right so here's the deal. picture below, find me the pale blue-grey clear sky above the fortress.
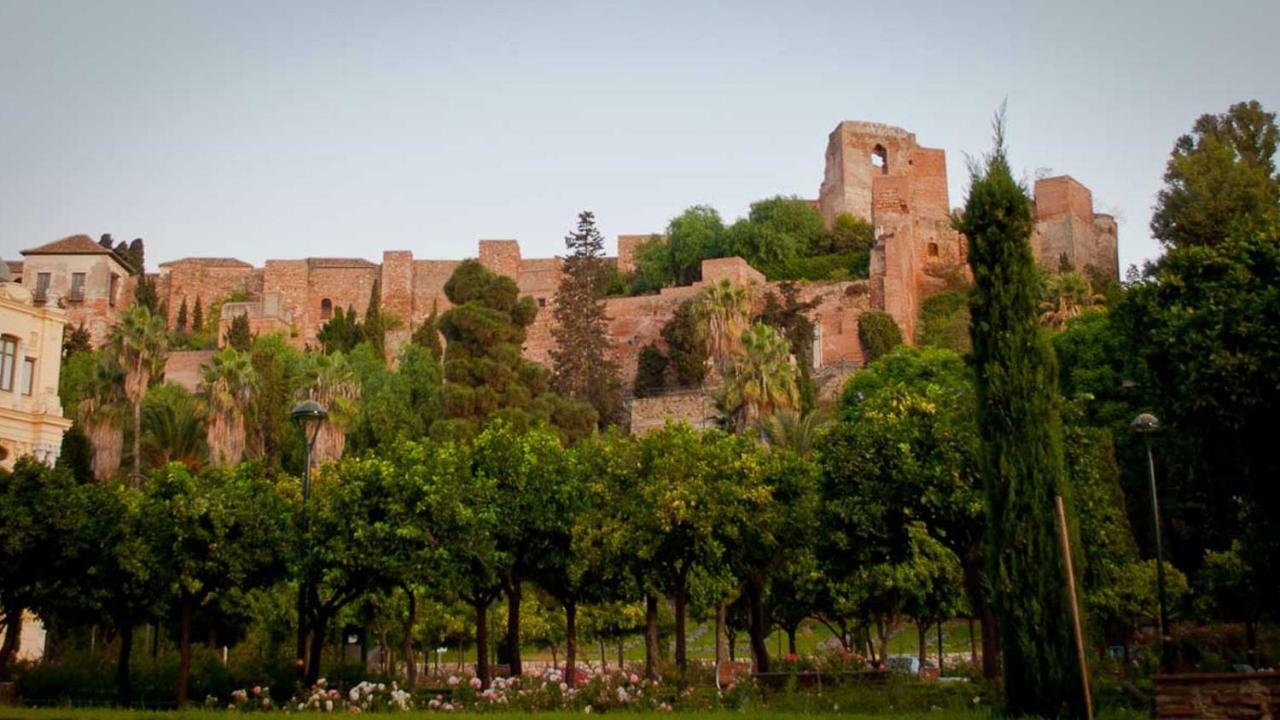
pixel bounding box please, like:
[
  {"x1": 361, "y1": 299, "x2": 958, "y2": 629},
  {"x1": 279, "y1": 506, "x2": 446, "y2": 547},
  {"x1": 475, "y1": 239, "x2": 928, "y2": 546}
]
[{"x1": 0, "y1": 0, "x2": 1280, "y2": 270}]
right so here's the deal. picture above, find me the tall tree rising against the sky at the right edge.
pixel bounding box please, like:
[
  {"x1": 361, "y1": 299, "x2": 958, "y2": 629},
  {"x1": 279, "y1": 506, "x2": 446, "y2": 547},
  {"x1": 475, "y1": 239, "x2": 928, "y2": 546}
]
[{"x1": 1151, "y1": 100, "x2": 1280, "y2": 249}]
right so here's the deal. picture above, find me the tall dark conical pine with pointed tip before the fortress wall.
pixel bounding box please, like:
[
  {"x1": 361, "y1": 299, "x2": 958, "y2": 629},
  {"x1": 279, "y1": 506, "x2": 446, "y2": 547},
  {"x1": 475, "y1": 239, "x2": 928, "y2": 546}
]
[{"x1": 550, "y1": 211, "x2": 622, "y2": 425}]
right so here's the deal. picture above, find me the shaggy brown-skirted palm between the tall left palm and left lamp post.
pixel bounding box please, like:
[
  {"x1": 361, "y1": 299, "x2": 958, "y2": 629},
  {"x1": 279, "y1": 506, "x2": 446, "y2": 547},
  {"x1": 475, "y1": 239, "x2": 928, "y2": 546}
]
[{"x1": 200, "y1": 347, "x2": 257, "y2": 465}]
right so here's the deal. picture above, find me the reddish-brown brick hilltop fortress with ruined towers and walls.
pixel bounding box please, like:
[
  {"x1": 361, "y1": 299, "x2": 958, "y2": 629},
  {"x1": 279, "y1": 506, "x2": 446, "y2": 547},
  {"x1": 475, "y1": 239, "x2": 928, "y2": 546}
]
[{"x1": 20, "y1": 122, "x2": 1119, "y2": 397}]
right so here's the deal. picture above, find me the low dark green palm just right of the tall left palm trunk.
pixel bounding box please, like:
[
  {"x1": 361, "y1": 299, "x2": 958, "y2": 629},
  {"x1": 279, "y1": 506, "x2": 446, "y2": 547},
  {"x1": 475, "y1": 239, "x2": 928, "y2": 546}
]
[{"x1": 142, "y1": 384, "x2": 209, "y2": 470}]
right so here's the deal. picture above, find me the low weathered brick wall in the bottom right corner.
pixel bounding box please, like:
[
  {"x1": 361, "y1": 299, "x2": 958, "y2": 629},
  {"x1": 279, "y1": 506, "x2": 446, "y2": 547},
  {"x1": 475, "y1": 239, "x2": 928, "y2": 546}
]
[{"x1": 1156, "y1": 673, "x2": 1280, "y2": 720}]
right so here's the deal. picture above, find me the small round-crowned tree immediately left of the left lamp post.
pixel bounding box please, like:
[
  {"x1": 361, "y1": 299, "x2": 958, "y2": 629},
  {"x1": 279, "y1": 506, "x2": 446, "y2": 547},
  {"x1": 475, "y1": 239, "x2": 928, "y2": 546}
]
[{"x1": 145, "y1": 464, "x2": 288, "y2": 708}]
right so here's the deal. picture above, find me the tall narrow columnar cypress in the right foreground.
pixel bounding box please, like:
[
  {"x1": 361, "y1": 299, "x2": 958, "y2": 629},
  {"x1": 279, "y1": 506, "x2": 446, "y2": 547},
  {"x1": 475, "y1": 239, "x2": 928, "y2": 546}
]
[{"x1": 955, "y1": 111, "x2": 1084, "y2": 717}]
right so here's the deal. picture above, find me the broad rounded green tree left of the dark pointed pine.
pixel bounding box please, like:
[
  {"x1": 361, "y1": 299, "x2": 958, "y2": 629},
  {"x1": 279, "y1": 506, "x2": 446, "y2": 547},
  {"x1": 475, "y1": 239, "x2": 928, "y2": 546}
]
[{"x1": 431, "y1": 254, "x2": 596, "y2": 439}]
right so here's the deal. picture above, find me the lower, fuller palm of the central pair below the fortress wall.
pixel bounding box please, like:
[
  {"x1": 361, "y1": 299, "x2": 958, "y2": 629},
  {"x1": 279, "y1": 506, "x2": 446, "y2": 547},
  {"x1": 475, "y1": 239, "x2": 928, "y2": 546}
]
[{"x1": 717, "y1": 323, "x2": 800, "y2": 430}]
